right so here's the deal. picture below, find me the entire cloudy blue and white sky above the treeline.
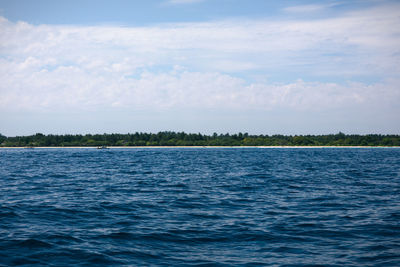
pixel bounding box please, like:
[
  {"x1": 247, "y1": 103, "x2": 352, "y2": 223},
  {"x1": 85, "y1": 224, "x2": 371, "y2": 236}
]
[{"x1": 0, "y1": 0, "x2": 400, "y2": 136}]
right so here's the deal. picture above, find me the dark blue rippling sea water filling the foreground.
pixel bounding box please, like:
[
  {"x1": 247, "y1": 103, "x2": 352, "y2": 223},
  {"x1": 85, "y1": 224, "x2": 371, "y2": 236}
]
[{"x1": 0, "y1": 148, "x2": 400, "y2": 266}]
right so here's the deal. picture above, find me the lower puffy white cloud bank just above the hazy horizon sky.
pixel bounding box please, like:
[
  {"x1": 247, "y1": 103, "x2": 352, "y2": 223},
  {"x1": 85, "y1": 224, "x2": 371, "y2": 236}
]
[{"x1": 0, "y1": 59, "x2": 400, "y2": 113}]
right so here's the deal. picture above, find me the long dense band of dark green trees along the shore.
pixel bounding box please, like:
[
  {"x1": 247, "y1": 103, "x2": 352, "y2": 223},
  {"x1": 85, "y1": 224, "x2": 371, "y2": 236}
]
[{"x1": 0, "y1": 132, "x2": 400, "y2": 147}]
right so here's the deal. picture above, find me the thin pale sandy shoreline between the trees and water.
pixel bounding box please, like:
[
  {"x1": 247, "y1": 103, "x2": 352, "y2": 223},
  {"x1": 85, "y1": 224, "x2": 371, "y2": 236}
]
[{"x1": 0, "y1": 146, "x2": 400, "y2": 149}]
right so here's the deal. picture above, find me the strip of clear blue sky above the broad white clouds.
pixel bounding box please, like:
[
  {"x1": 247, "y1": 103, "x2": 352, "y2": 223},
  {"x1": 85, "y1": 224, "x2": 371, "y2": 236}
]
[{"x1": 2, "y1": 0, "x2": 362, "y2": 26}]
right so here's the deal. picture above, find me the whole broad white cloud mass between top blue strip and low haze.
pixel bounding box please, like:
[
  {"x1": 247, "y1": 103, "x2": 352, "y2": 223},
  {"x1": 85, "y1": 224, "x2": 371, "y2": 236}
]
[{"x1": 0, "y1": 2, "x2": 400, "y2": 114}]
